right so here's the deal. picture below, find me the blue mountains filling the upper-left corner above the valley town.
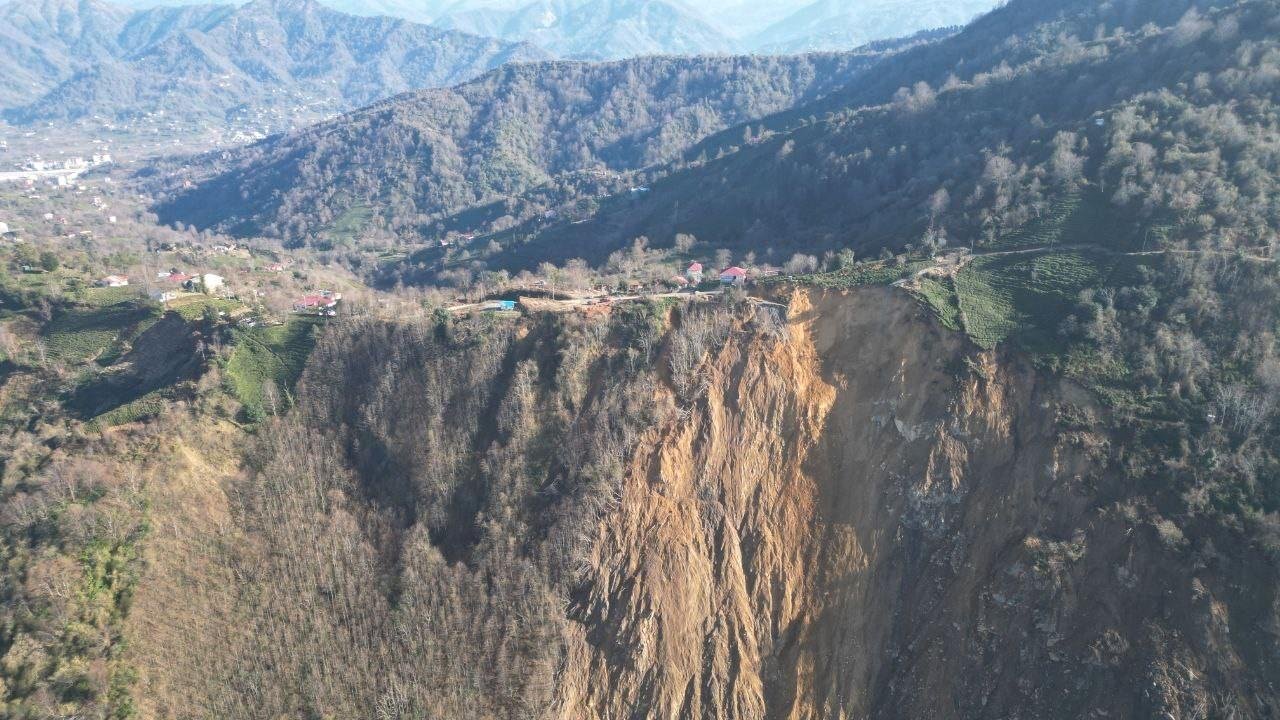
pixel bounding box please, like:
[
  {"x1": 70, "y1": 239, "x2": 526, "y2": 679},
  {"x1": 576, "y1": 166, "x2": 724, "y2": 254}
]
[{"x1": 0, "y1": 0, "x2": 549, "y2": 127}]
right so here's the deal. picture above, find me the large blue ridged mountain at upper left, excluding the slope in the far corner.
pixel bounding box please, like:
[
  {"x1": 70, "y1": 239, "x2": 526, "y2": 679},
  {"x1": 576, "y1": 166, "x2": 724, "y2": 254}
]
[{"x1": 5, "y1": 0, "x2": 545, "y2": 127}]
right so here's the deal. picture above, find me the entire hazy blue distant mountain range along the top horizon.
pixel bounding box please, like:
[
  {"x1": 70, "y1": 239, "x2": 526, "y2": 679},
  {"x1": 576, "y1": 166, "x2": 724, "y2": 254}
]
[{"x1": 0, "y1": 0, "x2": 996, "y2": 132}]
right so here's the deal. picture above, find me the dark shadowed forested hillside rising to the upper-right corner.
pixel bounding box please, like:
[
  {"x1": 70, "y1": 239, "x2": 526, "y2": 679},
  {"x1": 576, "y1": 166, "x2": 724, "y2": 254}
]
[{"x1": 481, "y1": 1, "x2": 1280, "y2": 265}]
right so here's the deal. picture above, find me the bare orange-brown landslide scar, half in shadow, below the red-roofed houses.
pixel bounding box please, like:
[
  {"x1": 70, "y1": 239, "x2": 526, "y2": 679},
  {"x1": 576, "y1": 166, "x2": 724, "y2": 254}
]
[{"x1": 558, "y1": 291, "x2": 1276, "y2": 719}]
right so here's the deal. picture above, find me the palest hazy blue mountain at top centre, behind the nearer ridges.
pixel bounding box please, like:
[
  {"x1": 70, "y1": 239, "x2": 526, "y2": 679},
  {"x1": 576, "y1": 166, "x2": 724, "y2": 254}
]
[{"x1": 435, "y1": 0, "x2": 737, "y2": 59}]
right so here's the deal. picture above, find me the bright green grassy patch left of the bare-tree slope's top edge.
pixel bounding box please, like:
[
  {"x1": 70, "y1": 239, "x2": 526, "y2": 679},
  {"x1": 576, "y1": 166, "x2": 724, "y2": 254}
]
[{"x1": 227, "y1": 318, "x2": 323, "y2": 415}]
